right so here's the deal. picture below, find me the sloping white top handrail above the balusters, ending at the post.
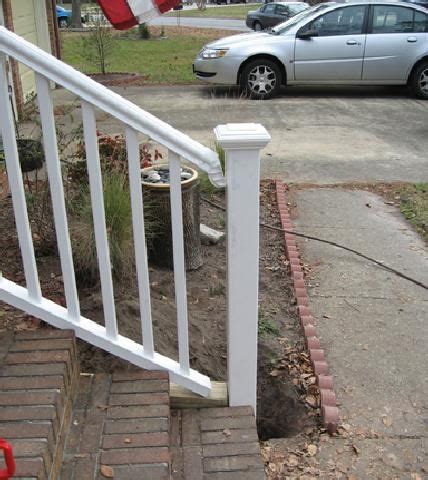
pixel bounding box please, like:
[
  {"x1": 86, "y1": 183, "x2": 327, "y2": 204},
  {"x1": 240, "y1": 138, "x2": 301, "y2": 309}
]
[{"x1": 0, "y1": 26, "x2": 225, "y2": 187}]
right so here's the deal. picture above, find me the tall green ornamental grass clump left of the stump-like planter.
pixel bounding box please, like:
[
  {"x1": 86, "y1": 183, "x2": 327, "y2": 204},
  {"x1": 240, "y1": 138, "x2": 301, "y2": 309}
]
[{"x1": 67, "y1": 133, "x2": 162, "y2": 285}]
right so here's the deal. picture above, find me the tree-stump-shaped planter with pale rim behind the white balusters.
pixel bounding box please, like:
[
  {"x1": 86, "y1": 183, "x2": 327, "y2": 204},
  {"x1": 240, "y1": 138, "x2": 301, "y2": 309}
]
[{"x1": 142, "y1": 167, "x2": 202, "y2": 270}]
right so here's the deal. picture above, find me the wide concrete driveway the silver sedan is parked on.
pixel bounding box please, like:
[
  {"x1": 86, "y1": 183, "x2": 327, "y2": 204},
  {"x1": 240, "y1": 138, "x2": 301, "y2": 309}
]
[{"x1": 51, "y1": 85, "x2": 428, "y2": 184}]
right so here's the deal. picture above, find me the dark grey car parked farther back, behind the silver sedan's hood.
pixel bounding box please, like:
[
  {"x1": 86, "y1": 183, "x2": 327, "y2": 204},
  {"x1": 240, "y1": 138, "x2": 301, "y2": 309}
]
[{"x1": 246, "y1": 2, "x2": 309, "y2": 32}]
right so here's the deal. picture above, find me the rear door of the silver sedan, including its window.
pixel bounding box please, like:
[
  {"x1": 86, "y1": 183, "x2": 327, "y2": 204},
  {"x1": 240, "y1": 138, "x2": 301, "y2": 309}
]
[{"x1": 363, "y1": 4, "x2": 428, "y2": 82}]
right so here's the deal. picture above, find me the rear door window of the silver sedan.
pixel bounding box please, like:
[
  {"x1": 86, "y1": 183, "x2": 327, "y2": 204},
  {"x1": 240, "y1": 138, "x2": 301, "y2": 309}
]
[{"x1": 372, "y1": 5, "x2": 414, "y2": 33}]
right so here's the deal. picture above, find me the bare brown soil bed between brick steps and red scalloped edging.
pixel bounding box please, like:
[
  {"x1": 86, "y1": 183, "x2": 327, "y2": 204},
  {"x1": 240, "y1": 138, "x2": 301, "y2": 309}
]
[{"x1": 0, "y1": 178, "x2": 323, "y2": 478}]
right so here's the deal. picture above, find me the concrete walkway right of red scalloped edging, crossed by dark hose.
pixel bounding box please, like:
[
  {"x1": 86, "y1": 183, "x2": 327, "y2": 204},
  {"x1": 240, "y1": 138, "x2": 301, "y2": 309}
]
[{"x1": 295, "y1": 189, "x2": 428, "y2": 479}]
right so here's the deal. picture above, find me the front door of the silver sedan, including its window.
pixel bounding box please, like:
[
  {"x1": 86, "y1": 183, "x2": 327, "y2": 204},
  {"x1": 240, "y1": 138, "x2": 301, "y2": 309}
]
[{"x1": 294, "y1": 5, "x2": 368, "y2": 82}]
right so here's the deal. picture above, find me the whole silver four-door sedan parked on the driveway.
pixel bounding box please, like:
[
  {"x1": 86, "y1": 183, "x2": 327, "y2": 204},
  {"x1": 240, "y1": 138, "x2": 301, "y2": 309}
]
[{"x1": 193, "y1": 0, "x2": 428, "y2": 99}]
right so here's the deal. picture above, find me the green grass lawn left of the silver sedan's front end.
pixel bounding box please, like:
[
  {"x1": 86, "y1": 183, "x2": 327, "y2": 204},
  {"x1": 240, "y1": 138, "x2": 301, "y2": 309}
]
[{"x1": 62, "y1": 27, "x2": 230, "y2": 83}]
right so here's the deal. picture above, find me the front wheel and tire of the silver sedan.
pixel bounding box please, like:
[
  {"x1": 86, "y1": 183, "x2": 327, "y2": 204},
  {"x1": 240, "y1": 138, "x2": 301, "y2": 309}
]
[{"x1": 240, "y1": 58, "x2": 282, "y2": 100}]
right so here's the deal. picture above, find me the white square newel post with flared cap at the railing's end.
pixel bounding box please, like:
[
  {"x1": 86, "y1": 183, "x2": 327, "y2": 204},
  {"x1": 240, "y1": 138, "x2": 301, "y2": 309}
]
[{"x1": 214, "y1": 123, "x2": 271, "y2": 413}]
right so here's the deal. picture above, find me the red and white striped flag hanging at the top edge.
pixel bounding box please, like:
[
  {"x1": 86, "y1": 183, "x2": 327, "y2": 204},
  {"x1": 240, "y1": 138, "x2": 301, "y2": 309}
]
[{"x1": 98, "y1": 0, "x2": 180, "y2": 30}]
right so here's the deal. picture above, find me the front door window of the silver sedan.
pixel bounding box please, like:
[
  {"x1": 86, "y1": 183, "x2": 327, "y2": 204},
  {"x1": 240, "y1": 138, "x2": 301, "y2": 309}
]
[{"x1": 304, "y1": 5, "x2": 366, "y2": 37}]
